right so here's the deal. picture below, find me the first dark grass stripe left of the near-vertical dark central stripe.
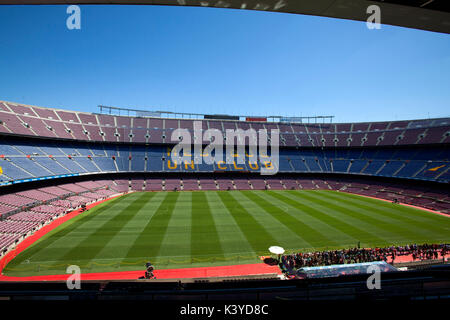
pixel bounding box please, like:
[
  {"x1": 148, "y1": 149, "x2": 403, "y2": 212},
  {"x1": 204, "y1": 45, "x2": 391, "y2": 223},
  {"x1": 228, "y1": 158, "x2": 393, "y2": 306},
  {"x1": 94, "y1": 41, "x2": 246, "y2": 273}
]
[{"x1": 126, "y1": 191, "x2": 179, "y2": 259}]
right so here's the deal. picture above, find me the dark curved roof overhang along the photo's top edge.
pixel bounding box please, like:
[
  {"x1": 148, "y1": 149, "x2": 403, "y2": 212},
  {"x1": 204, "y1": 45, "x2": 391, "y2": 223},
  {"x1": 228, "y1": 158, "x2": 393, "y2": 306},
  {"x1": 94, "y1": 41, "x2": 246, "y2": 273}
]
[{"x1": 0, "y1": 0, "x2": 450, "y2": 33}]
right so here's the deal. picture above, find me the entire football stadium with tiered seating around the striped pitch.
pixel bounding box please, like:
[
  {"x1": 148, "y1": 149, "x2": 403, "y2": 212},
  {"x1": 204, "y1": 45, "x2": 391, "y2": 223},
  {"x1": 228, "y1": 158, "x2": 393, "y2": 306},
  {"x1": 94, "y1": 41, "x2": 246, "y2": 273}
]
[{"x1": 0, "y1": 1, "x2": 450, "y2": 300}]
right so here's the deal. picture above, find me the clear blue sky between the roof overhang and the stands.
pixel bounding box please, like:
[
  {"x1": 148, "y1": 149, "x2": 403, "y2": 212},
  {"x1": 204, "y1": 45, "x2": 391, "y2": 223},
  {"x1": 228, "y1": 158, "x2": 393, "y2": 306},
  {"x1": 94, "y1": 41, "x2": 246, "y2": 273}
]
[{"x1": 0, "y1": 6, "x2": 450, "y2": 122}]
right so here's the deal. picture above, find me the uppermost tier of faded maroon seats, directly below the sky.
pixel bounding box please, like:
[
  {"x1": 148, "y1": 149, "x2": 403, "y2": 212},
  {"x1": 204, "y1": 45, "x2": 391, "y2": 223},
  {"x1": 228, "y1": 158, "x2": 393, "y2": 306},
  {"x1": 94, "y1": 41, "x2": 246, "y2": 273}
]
[{"x1": 0, "y1": 101, "x2": 450, "y2": 146}]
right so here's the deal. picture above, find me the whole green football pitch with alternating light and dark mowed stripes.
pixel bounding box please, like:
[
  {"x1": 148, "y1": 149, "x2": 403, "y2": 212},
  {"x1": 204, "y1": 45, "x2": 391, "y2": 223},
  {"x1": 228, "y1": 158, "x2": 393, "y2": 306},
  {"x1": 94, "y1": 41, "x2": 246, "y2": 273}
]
[{"x1": 4, "y1": 190, "x2": 450, "y2": 276}]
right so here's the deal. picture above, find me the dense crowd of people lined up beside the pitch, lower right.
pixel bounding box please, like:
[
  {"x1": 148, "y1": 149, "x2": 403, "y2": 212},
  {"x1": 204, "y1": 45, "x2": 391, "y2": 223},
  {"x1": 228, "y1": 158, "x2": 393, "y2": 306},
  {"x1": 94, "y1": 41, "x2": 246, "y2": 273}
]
[{"x1": 281, "y1": 244, "x2": 450, "y2": 269}]
